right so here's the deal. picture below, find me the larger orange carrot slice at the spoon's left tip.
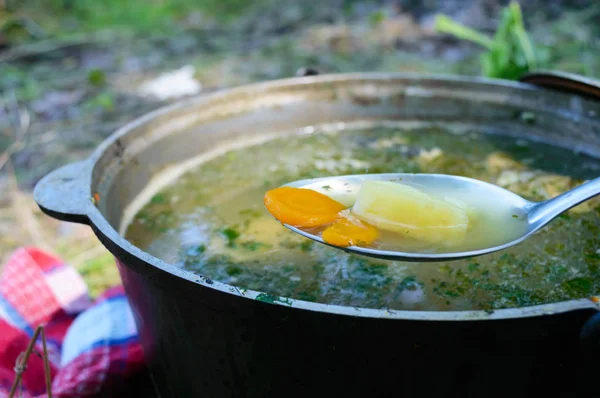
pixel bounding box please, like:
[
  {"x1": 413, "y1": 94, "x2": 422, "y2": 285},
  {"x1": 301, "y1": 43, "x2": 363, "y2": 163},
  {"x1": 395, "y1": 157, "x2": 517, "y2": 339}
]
[{"x1": 264, "y1": 187, "x2": 345, "y2": 228}]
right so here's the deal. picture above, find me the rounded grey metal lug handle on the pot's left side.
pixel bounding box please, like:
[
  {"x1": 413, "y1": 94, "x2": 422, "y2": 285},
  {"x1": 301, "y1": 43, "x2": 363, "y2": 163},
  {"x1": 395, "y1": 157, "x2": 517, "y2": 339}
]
[{"x1": 33, "y1": 160, "x2": 93, "y2": 224}]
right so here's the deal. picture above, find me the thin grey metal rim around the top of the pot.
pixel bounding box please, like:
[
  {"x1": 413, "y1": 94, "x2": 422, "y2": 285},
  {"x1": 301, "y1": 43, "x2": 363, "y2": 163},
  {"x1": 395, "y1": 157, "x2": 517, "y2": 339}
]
[{"x1": 35, "y1": 72, "x2": 600, "y2": 321}]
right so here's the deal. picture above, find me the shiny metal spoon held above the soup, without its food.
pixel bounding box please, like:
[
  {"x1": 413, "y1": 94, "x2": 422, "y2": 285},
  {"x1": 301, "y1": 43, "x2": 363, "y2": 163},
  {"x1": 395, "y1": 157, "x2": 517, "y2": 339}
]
[{"x1": 276, "y1": 173, "x2": 600, "y2": 262}]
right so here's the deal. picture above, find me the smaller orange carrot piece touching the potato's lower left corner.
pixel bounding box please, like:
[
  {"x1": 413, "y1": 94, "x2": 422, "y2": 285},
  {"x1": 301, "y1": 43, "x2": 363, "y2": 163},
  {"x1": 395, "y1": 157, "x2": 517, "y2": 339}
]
[{"x1": 321, "y1": 218, "x2": 379, "y2": 247}]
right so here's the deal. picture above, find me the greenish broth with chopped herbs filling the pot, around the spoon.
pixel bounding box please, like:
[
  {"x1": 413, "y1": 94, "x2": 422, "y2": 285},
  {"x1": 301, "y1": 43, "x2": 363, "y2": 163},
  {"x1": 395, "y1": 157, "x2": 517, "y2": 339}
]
[{"x1": 125, "y1": 126, "x2": 600, "y2": 310}]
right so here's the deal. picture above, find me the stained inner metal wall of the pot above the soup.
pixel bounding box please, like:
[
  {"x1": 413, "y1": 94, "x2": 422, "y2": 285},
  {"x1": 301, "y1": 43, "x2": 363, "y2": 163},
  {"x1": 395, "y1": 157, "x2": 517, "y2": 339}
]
[{"x1": 92, "y1": 75, "x2": 600, "y2": 233}]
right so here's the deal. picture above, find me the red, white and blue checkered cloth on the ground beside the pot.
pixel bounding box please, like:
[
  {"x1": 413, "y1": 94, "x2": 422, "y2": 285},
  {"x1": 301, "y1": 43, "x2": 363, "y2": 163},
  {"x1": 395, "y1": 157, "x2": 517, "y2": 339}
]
[{"x1": 0, "y1": 248, "x2": 144, "y2": 398}]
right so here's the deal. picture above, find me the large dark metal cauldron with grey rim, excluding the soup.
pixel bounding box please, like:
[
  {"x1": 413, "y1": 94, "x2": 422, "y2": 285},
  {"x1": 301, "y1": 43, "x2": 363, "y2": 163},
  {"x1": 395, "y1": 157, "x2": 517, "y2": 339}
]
[{"x1": 34, "y1": 73, "x2": 600, "y2": 398}]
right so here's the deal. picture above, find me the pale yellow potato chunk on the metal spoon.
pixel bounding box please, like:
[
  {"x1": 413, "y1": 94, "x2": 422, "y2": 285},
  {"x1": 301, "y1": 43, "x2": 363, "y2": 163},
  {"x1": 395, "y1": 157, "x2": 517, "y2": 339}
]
[{"x1": 352, "y1": 181, "x2": 469, "y2": 247}]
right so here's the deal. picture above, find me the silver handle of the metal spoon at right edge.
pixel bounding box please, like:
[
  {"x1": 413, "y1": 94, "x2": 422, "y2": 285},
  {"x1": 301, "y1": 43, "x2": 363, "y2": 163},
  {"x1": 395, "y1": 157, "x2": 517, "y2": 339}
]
[{"x1": 529, "y1": 177, "x2": 600, "y2": 227}]
